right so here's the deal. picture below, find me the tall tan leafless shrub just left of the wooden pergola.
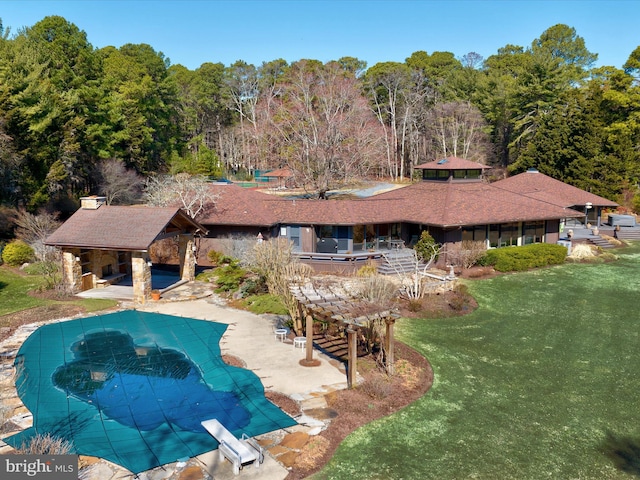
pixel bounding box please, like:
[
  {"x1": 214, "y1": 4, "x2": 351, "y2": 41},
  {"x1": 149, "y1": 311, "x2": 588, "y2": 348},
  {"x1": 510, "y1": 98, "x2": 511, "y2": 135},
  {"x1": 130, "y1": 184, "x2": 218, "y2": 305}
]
[{"x1": 249, "y1": 238, "x2": 312, "y2": 333}]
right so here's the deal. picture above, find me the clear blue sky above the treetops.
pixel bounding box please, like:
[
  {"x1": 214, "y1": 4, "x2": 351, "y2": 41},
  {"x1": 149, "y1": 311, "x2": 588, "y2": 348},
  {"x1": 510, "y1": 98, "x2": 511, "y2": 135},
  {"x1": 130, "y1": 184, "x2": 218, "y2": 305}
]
[{"x1": 0, "y1": 0, "x2": 640, "y2": 70}]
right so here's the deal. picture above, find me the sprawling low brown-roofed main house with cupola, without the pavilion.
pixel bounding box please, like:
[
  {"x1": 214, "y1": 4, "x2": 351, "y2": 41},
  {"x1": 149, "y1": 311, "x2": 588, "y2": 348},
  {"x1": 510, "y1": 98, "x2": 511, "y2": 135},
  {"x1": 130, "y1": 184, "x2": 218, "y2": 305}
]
[{"x1": 198, "y1": 157, "x2": 617, "y2": 268}]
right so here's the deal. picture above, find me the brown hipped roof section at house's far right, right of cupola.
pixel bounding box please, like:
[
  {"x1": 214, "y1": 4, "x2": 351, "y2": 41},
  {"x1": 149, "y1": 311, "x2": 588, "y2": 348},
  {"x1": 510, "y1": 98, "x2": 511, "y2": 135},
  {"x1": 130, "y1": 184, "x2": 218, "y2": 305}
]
[{"x1": 491, "y1": 170, "x2": 618, "y2": 208}]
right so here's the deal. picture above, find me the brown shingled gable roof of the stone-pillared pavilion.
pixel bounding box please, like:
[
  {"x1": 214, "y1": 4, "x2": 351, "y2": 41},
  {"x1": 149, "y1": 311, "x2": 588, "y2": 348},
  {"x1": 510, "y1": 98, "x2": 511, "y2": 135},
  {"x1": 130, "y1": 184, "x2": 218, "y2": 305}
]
[{"x1": 45, "y1": 205, "x2": 206, "y2": 251}]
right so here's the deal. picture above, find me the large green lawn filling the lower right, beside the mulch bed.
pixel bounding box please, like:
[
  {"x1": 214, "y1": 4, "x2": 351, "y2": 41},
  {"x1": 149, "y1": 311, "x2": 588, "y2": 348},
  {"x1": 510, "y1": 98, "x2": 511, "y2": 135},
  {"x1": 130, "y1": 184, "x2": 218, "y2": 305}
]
[{"x1": 314, "y1": 245, "x2": 640, "y2": 480}]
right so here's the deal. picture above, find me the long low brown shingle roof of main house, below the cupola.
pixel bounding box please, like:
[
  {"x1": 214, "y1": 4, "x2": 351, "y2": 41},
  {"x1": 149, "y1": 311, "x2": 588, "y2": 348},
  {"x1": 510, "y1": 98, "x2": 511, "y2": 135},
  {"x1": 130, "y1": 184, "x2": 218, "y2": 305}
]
[{"x1": 199, "y1": 182, "x2": 583, "y2": 231}]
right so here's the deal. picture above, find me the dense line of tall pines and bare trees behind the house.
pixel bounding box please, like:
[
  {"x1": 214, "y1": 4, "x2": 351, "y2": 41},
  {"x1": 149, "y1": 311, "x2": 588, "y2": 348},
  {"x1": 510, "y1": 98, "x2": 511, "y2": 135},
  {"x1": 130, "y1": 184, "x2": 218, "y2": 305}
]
[{"x1": 0, "y1": 16, "x2": 640, "y2": 211}]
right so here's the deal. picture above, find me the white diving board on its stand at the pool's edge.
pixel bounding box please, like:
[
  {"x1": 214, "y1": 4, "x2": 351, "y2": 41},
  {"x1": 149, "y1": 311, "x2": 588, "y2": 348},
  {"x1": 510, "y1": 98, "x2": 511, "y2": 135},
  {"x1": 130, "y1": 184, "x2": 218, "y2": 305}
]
[{"x1": 201, "y1": 418, "x2": 264, "y2": 475}]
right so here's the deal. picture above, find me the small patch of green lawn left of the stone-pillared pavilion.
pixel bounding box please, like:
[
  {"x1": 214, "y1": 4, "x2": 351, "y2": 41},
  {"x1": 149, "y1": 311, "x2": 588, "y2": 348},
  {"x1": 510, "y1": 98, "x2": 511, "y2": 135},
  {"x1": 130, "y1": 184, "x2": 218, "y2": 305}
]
[{"x1": 0, "y1": 266, "x2": 117, "y2": 316}]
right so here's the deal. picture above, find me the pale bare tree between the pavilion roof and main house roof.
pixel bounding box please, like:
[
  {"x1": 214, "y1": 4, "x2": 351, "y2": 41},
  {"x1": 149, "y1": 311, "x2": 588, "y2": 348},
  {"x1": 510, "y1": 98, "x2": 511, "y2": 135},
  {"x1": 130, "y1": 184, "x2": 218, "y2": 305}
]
[{"x1": 145, "y1": 173, "x2": 220, "y2": 218}]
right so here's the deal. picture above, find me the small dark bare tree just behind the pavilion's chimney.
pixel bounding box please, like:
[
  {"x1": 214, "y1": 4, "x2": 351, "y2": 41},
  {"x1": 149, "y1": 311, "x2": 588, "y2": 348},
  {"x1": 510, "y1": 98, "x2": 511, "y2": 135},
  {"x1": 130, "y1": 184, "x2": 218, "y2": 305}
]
[{"x1": 97, "y1": 158, "x2": 144, "y2": 205}]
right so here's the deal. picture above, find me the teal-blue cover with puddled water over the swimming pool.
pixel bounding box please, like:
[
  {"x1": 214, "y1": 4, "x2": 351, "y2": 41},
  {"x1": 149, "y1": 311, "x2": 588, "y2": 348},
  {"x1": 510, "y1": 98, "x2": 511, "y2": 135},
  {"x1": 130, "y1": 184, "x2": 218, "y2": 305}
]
[{"x1": 5, "y1": 310, "x2": 296, "y2": 473}]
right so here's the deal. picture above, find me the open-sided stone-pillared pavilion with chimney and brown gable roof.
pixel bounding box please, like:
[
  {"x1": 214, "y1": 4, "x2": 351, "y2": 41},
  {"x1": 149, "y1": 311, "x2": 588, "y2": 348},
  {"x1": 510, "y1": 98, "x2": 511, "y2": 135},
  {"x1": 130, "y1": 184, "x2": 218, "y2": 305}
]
[{"x1": 45, "y1": 197, "x2": 206, "y2": 304}]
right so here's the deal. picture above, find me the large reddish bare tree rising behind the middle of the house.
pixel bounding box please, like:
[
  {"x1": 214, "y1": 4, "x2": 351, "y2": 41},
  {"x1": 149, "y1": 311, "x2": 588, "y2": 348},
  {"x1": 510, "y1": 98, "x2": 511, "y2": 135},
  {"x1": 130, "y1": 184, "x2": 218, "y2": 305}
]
[{"x1": 259, "y1": 60, "x2": 383, "y2": 198}]
